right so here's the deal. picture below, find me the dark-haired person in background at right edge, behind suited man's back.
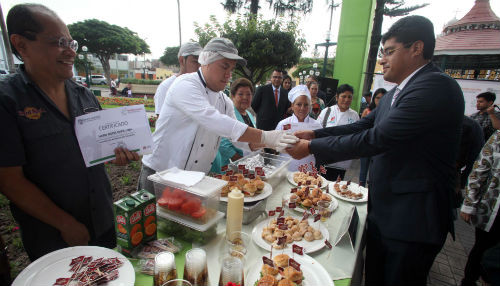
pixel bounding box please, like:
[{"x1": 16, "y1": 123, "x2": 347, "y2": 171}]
[{"x1": 470, "y1": 91, "x2": 500, "y2": 141}]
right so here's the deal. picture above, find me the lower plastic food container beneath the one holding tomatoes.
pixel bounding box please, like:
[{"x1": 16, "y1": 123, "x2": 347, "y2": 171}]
[{"x1": 157, "y1": 209, "x2": 224, "y2": 245}]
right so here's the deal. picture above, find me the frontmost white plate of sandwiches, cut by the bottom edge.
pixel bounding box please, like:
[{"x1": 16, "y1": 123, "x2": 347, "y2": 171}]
[{"x1": 245, "y1": 250, "x2": 335, "y2": 286}]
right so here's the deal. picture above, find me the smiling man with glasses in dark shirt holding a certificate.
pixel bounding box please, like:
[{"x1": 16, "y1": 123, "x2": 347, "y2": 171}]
[{"x1": 0, "y1": 4, "x2": 139, "y2": 261}]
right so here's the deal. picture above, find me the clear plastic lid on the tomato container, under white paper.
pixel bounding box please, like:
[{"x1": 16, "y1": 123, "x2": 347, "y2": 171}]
[{"x1": 148, "y1": 170, "x2": 227, "y2": 197}]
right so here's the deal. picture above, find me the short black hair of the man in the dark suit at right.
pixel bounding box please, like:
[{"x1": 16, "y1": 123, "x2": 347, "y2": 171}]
[{"x1": 382, "y1": 15, "x2": 436, "y2": 60}]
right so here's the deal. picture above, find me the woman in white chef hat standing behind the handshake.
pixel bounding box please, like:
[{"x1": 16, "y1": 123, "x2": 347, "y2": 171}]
[{"x1": 276, "y1": 85, "x2": 321, "y2": 172}]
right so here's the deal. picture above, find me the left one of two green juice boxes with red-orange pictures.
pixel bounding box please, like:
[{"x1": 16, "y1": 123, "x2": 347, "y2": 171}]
[{"x1": 114, "y1": 197, "x2": 144, "y2": 256}]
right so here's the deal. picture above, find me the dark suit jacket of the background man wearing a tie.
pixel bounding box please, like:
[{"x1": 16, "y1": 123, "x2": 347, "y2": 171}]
[{"x1": 252, "y1": 84, "x2": 290, "y2": 130}]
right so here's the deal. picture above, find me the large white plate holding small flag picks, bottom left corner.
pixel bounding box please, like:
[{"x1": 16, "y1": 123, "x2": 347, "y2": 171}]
[{"x1": 12, "y1": 246, "x2": 135, "y2": 286}]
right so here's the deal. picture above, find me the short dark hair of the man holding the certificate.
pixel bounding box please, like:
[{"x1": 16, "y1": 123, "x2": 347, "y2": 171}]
[{"x1": 7, "y1": 4, "x2": 59, "y2": 60}]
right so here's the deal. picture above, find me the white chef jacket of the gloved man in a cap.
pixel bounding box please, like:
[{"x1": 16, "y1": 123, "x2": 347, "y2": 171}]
[{"x1": 142, "y1": 69, "x2": 248, "y2": 173}]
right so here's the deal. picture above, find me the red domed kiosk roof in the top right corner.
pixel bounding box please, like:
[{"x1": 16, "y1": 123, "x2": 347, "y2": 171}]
[{"x1": 433, "y1": 0, "x2": 500, "y2": 80}]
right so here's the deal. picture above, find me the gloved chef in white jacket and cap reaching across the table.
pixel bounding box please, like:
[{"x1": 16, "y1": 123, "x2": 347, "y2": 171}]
[{"x1": 138, "y1": 38, "x2": 298, "y2": 191}]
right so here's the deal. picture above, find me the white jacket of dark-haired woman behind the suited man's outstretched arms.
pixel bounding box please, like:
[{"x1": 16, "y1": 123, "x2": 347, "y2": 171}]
[{"x1": 317, "y1": 104, "x2": 359, "y2": 170}]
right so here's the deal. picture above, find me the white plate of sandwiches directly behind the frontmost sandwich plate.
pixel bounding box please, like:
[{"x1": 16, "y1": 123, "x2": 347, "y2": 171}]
[{"x1": 252, "y1": 217, "x2": 330, "y2": 253}]
